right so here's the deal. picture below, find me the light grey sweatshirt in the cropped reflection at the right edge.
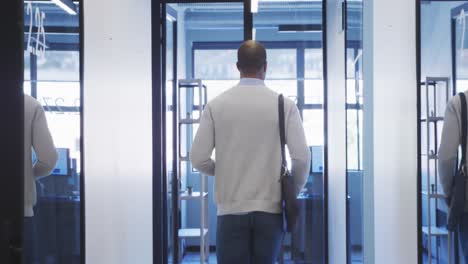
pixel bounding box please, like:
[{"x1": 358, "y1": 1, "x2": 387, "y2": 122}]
[{"x1": 439, "y1": 92, "x2": 468, "y2": 211}]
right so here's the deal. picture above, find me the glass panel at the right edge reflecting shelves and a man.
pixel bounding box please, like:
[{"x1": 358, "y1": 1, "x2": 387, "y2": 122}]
[{"x1": 418, "y1": 1, "x2": 468, "y2": 263}]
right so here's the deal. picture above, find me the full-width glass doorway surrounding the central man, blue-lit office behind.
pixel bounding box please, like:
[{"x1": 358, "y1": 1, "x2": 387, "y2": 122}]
[{"x1": 162, "y1": 0, "x2": 328, "y2": 263}]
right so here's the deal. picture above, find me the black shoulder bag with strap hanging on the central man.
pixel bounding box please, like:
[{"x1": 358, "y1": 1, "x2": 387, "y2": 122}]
[{"x1": 278, "y1": 94, "x2": 299, "y2": 232}]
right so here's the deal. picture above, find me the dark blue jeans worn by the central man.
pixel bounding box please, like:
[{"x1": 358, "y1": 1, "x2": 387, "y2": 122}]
[{"x1": 216, "y1": 212, "x2": 284, "y2": 264}]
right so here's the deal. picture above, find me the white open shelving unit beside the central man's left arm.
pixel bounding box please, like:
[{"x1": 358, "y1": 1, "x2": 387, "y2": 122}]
[{"x1": 178, "y1": 79, "x2": 210, "y2": 264}]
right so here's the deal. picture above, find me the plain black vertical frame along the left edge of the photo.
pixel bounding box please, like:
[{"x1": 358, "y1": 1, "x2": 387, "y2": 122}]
[{"x1": 0, "y1": 1, "x2": 24, "y2": 264}]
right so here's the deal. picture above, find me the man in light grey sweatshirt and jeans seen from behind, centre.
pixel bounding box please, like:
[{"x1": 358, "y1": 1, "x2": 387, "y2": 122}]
[{"x1": 190, "y1": 41, "x2": 310, "y2": 264}]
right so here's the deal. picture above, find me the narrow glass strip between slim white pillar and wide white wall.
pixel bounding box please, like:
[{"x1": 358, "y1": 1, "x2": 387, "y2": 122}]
[{"x1": 345, "y1": 0, "x2": 364, "y2": 264}]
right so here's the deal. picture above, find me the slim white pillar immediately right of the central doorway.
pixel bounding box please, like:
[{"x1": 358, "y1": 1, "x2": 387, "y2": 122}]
[{"x1": 326, "y1": 0, "x2": 346, "y2": 264}]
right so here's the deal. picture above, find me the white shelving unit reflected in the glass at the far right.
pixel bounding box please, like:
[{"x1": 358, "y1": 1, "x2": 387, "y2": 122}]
[{"x1": 421, "y1": 77, "x2": 452, "y2": 264}]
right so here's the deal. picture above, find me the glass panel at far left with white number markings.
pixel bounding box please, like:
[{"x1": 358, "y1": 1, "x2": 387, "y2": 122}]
[{"x1": 24, "y1": 0, "x2": 83, "y2": 264}]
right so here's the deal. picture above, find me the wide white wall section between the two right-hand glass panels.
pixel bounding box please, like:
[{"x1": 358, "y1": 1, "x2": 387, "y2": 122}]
[{"x1": 364, "y1": 0, "x2": 418, "y2": 264}]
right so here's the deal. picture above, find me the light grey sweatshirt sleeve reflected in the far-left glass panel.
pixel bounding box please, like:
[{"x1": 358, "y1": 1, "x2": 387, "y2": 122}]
[{"x1": 24, "y1": 95, "x2": 58, "y2": 217}]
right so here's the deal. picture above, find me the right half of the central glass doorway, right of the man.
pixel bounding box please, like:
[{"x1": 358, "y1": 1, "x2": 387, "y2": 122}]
[{"x1": 251, "y1": 1, "x2": 327, "y2": 263}]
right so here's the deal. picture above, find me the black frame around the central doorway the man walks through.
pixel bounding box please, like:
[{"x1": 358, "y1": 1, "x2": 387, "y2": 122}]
[{"x1": 151, "y1": 0, "x2": 329, "y2": 264}]
